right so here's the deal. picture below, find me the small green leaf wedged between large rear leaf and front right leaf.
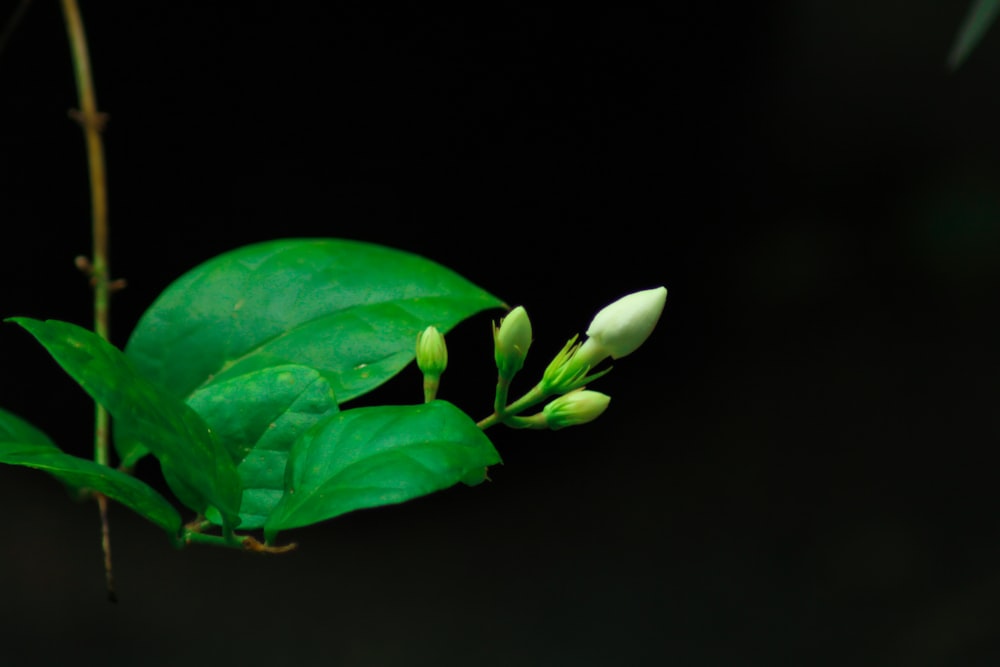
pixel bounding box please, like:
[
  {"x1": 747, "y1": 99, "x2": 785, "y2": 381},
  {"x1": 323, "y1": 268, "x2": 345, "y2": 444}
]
[{"x1": 188, "y1": 366, "x2": 339, "y2": 529}]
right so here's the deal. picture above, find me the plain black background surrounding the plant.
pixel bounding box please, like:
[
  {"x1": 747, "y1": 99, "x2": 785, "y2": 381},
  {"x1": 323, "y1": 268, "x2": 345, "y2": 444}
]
[{"x1": 0, "y1": 0, "x2": 1000, "y2": 667}]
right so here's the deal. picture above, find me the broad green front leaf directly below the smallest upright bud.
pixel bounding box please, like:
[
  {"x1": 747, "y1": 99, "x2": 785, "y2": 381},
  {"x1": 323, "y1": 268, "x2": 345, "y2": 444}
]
[{"x1": 264, "y1": 401, "x2": 500, "y2": 541}]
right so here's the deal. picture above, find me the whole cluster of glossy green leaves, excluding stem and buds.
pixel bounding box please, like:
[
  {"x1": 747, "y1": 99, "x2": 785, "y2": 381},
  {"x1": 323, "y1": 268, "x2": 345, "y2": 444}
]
[{"x1": 0, "y1": 239, "x2": 503, "y2": 545}]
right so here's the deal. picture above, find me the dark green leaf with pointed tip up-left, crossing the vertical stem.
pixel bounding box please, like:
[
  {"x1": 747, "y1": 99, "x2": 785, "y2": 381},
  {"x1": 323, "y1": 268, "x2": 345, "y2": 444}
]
[{"x1": 10, "y1": 317, "x2": 240, "y2": 530}]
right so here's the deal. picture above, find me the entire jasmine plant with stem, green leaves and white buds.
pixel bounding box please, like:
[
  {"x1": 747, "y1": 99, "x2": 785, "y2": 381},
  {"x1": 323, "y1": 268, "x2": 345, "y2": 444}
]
[{"x1": 0, "y1": 0, "x2": 667, "y2": 599}]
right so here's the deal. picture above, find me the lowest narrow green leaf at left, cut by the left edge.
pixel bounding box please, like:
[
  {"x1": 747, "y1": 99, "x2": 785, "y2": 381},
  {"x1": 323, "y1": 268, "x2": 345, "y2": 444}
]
[{"x1": 0, "y1": 436, "x2": 181, "y2": 536}]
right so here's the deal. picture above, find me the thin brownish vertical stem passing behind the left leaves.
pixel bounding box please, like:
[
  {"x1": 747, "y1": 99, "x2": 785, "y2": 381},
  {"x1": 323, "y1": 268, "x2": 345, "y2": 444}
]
[{"x1": 62, "y1": 0, "x2": 115, "y2": 600}]
